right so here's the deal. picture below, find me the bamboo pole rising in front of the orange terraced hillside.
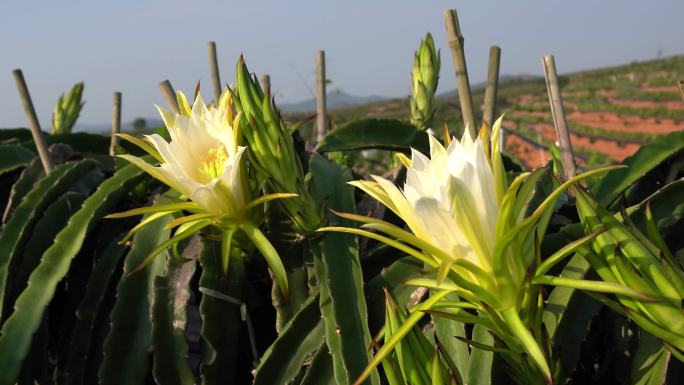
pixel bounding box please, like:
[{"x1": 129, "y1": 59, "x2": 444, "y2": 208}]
[{"x1": 542, "y1": 55, "x2": 577, "y2": 178}]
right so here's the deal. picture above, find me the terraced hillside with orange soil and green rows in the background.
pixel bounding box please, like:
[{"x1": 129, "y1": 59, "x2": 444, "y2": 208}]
[{"x1": 293, "y1": 56, "x2": 684, "y2": 168}]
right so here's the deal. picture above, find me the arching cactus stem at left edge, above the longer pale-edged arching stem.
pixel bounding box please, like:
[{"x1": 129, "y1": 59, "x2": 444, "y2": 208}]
[{"x1": 0, "y1": 160, "x2": 96, "y2": 316}]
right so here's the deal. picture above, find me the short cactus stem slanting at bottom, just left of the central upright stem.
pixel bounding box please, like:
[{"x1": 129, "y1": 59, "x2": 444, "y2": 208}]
[{"x1": 254, "y1": 294, "x2": 325, "y2": 385}]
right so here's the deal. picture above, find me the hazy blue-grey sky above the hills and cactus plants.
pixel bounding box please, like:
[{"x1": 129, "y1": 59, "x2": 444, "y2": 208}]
[{"x1": 0, "y1": 0, "x2": 684, "y2": 129}]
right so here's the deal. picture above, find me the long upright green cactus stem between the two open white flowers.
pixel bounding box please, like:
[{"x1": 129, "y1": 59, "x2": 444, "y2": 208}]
[{"x1": 310, "y1": 154, "x2": 379, "y2": 384}]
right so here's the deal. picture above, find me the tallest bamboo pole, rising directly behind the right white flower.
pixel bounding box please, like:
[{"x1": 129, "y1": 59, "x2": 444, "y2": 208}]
[{"x1": 444, "y1": 9, "x2": 477, "y2": 137}]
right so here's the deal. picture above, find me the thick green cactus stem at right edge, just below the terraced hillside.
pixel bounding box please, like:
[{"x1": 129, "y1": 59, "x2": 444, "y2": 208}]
[{"x1": 592, "y1": 131, "x2": 684, "y2": 207}]
